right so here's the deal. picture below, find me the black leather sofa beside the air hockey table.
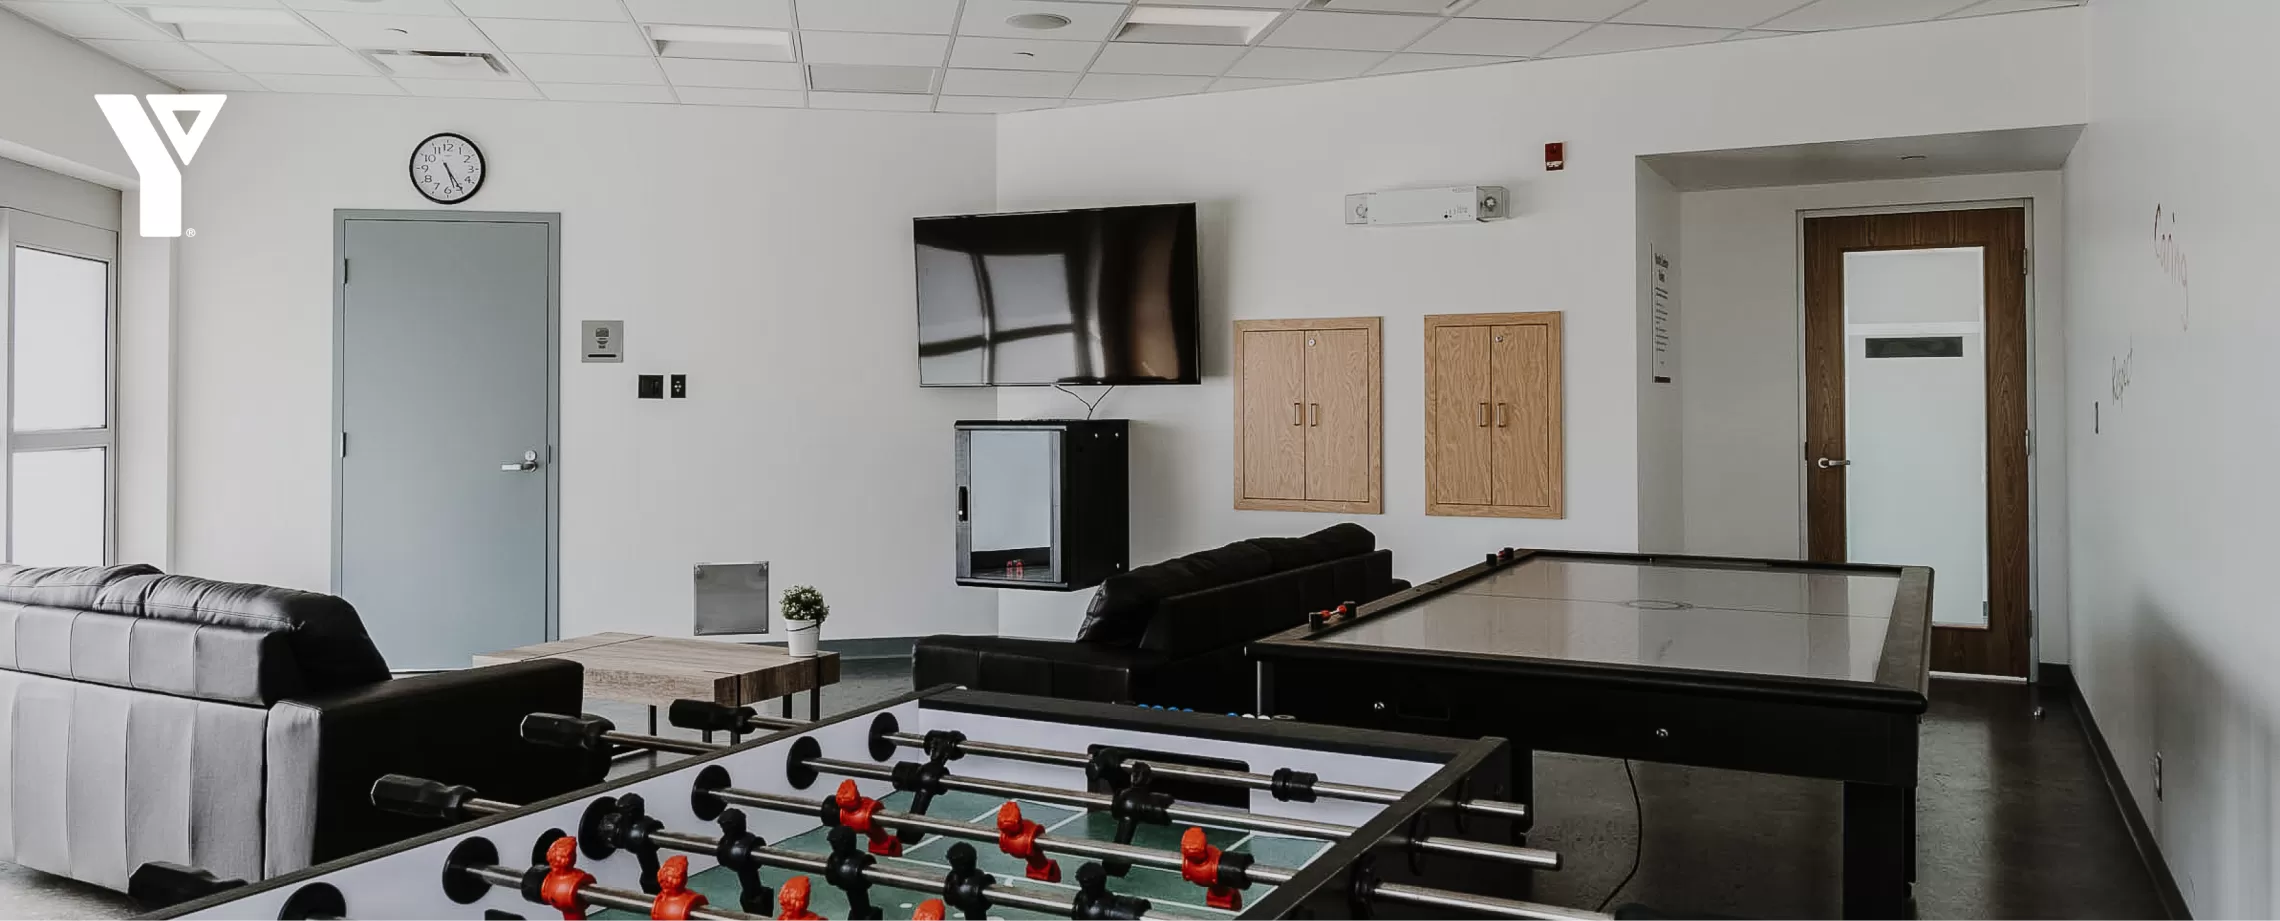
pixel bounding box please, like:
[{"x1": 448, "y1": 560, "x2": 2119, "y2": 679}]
[{"x1": 912, "y1": 524, "x2": 1407, "y2": 714}]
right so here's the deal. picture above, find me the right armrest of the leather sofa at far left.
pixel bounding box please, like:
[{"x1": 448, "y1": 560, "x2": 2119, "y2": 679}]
[{"x1": 262, "y1": 659, "x2": 609, "y2": 875}]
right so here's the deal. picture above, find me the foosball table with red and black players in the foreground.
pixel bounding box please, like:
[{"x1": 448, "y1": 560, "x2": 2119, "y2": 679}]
[{"x1": 135, "y1": 688, "x2": 1605, "y2": 919}]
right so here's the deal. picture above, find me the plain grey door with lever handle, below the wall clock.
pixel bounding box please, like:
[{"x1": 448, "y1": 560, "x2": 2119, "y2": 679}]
[{"x1": 333, "y1": 219, "x2": 554, "y2": 670}]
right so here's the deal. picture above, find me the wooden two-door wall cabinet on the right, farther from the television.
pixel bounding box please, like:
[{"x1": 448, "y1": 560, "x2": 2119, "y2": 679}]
[{"x1": 1425, "y1": 312, "x2": 1566, "y2": 517}]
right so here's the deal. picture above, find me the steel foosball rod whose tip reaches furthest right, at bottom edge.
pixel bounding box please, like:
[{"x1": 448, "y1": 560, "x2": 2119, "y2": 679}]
[{"x1": 705, "y1": 786, "x2": 1612, "y2": 921}]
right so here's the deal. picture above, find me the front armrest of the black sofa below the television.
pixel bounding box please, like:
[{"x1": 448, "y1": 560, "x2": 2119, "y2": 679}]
[{"x1": 910, "y1": 636, "x2": 1167, "y2": 702}]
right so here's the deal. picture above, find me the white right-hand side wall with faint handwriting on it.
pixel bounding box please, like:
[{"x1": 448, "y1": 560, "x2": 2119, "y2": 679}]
[{"x1": 2066, "y1": 0, "x2": 2280, "y2": 916}]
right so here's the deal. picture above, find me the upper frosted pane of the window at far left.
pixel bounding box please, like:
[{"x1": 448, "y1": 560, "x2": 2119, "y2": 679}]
[{"x1": 11, "y1": 246, "x2": 112, "y2": 431}]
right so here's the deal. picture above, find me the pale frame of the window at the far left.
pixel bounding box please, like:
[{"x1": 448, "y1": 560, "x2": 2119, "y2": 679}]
[{"x1": 0, "y1": 207, "x2": 119, "y2": 565}]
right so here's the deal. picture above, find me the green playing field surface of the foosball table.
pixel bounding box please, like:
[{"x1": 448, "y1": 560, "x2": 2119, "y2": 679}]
[{"x1": 593, "y1": 793, "x2": 1327, "y2": 919}]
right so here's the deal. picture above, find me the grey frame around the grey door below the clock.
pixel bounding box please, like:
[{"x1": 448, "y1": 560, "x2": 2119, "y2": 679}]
[{"x1": 326, "y1": 207, "x2": 563, "y2": 641}]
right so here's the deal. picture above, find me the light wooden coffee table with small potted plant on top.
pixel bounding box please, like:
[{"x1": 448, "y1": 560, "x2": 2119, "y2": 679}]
[{"x1": 474, "y1": 634, "x2": 839, "y2": 736}]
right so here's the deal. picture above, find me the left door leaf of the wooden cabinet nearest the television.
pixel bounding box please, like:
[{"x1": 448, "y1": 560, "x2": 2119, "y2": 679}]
[{"x1": 1236, "y1": 331, "x2": 1306, "y2": 502}]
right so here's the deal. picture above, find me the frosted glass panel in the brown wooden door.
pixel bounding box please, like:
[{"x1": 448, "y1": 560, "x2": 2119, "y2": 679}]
[{"x1": 1845, "y1": 246, "x2": 1988, "y2": 627}]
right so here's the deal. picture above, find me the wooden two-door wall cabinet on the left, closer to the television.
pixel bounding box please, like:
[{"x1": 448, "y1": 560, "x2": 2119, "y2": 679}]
[{"x1": 1236, "y1": 317, "x2": 1384, "y2": 515}]
